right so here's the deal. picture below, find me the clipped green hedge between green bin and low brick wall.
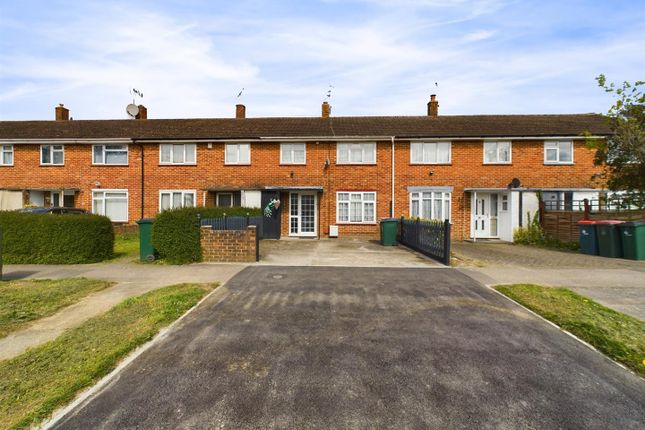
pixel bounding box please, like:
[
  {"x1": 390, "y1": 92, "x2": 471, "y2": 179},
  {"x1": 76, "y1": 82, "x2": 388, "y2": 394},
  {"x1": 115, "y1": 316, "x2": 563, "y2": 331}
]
[{"x1": 152, "y1": 207, "x2": 262, "y2": 264}]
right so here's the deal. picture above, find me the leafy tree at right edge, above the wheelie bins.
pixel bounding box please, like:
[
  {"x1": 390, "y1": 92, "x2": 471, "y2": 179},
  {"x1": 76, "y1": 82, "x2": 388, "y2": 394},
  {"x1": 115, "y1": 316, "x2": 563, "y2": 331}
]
[{"x1": 588, "y1": 75, "x2": 645, "y2": 207}]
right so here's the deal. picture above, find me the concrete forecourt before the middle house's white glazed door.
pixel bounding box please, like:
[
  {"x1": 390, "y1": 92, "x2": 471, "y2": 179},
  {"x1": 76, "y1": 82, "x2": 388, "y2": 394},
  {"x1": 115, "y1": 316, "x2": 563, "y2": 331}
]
[{"x1": 259, "y1": 239, "x2": 441, "y2": 267}]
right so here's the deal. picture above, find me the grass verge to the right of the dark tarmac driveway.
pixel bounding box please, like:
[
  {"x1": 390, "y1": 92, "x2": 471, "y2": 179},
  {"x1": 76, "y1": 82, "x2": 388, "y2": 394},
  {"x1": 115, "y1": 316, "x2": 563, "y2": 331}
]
[{"x1": 495, "y1": 284, "x2": 645, "y2": 377}]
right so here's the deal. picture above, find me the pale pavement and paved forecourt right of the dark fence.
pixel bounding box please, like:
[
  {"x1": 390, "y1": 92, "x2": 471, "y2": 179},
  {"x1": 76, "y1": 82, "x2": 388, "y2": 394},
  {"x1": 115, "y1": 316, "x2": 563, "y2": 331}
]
[{"x1": 453, "y1": 242, "x2": 645, "y2": 321}]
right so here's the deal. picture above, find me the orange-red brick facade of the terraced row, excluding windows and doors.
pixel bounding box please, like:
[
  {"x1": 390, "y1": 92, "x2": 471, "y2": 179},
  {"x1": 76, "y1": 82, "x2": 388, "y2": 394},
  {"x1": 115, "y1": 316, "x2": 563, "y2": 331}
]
[{"x1": 0, "y1": 139, "x2": 598, "y2": 239}]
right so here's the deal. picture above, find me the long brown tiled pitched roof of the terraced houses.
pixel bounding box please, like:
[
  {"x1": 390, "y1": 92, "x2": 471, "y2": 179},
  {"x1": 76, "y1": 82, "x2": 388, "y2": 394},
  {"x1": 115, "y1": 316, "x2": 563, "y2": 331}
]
[{"x1": 0, "y1": 114, "x2": 611, "y2": 139}]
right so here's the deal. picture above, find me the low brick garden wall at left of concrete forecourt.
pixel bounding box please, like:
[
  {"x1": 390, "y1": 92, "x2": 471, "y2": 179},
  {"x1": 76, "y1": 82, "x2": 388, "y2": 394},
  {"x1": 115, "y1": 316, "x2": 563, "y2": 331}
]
[{"x1": 200, "y1": 225, "x2": 257, "y2": 263}]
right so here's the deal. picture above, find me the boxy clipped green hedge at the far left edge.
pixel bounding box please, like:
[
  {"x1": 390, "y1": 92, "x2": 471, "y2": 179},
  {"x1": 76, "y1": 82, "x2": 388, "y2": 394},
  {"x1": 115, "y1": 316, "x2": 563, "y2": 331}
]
[{"x1": 0, "y1": 212, "x2": 114, "y2": 264}]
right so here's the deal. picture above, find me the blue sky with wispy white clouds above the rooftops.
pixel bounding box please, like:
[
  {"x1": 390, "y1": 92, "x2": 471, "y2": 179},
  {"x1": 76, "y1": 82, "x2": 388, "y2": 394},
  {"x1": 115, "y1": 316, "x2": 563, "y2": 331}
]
[{"x1": 0, "y1": 0, "x2": 645, "y2": 120}]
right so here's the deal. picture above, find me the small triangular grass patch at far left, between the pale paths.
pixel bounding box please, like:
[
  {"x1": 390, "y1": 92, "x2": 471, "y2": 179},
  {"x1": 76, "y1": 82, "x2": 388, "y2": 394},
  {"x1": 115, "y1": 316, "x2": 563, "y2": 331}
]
[{"x1": 0, "y1": 278, "x2": 113, "y2": 338}]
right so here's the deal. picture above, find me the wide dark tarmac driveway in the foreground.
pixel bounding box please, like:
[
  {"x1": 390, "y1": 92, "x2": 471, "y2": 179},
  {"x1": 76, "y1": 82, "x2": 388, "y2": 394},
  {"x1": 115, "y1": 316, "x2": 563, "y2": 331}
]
[{"x1": 52, "y1": 266, "x2": 645, "y2": 429}]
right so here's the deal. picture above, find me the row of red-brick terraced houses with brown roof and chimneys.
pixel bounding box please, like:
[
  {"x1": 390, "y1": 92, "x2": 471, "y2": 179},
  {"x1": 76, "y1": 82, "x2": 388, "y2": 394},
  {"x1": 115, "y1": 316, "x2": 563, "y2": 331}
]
[{"x1": 0, "y1": 96, "x2": 610, "y2": 240}]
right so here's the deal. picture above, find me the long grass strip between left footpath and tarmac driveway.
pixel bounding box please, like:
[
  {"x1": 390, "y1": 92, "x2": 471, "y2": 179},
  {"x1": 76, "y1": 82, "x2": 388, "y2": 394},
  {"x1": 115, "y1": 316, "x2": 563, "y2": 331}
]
[{"x1": 0, "y1": 284, "x2": 216, "y2": 428}]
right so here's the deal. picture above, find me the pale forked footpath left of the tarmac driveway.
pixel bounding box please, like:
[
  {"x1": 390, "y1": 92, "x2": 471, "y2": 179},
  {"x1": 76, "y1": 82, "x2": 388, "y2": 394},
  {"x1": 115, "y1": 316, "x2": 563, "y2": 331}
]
[{"x1": 0, "y1": 263, "x2": 246, "y2": 360}]
